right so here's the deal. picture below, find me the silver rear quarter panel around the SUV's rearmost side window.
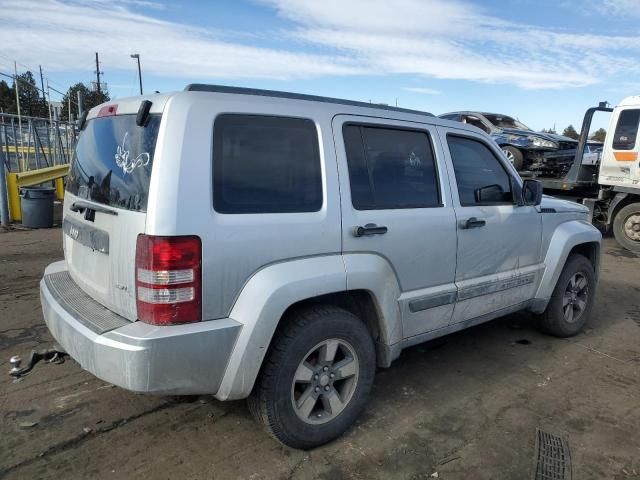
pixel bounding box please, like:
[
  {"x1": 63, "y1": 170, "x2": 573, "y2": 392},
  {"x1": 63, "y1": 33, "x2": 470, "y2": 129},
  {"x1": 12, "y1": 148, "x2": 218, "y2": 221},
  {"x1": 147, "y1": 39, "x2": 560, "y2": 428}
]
[{"x1": 146, "y1": 92, "x2": 341, "y2": 319}]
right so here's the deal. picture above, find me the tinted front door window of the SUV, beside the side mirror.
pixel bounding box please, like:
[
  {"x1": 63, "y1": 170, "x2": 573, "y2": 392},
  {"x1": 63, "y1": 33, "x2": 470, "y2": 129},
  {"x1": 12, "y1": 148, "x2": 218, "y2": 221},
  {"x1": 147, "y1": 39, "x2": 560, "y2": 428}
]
[{"x1": 447, "y1": 135, "x2": 513, "y2": 206}]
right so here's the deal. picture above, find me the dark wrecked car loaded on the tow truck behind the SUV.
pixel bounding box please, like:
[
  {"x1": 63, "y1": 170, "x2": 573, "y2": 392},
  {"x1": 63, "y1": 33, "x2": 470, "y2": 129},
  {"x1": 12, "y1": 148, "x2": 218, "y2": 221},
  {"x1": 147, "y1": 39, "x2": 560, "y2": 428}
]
[{"x1": 440, "y1": 112, "x2": 578, "y2": 171}]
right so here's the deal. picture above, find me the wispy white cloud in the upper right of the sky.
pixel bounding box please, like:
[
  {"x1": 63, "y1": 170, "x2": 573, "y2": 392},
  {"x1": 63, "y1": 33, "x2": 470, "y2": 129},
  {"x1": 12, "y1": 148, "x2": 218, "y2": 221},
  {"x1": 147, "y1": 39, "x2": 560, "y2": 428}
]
[{"x1": 265, "y1": 0, "x2": 640, "y2": 89}]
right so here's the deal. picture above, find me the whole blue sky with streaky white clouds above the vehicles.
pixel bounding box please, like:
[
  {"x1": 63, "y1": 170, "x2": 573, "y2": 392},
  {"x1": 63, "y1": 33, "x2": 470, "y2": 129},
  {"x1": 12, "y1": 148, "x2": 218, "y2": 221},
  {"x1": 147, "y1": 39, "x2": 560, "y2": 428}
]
[{"x1": 0, "y1": 0, "x2": 640, "y2": 130}]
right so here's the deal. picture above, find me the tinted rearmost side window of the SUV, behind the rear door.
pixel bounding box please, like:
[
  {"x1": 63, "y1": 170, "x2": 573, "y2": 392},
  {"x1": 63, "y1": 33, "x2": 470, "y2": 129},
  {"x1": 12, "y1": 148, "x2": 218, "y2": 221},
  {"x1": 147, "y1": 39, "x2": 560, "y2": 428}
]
[{"x1": 213, "y1": 114, "x2": 322, "y2": 213}]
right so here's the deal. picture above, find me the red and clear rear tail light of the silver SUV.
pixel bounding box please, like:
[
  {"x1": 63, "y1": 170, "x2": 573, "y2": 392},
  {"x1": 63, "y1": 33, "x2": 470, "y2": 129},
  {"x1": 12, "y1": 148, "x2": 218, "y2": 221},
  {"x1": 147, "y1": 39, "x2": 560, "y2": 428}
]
[{"x1": 136, "y1": 235, "x2": 202, "y2": 325}]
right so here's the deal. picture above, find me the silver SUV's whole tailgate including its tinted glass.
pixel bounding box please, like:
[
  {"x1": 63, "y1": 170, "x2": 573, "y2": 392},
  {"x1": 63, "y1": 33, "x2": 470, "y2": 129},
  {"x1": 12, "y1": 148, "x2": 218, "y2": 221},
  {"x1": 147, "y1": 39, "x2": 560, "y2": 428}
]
[{"x1": 63, "y1": 115, "x2": 160, "y2": 321}]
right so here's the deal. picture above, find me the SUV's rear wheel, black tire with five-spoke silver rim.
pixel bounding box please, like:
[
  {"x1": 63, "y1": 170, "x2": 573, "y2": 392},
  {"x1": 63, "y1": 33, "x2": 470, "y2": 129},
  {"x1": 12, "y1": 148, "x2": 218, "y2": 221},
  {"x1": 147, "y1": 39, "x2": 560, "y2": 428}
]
[{"x1": 248, "y1": 305, "x2": 376, "y2": 449}]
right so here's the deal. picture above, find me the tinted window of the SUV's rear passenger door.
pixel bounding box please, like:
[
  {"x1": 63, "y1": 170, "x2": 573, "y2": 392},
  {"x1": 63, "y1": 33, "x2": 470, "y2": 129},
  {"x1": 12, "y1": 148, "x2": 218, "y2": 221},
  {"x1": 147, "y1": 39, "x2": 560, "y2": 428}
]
[{"x1": 342, "y1": 124, "x2": 440, "y2": 210}]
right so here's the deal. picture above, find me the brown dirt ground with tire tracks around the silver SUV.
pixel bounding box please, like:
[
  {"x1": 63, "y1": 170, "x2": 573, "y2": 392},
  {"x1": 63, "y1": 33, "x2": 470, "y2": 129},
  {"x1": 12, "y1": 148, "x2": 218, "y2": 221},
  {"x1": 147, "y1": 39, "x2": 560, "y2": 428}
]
[{"x1": 0, "y1": 228, "x2": 640, "y2": 480}]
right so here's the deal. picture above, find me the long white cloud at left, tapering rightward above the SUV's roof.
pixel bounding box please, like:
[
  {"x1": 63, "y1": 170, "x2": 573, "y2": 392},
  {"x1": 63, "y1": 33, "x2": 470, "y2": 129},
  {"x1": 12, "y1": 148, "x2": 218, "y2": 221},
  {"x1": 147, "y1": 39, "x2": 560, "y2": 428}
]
[{"x1": 0, "y1": 0, "x2": 362, "y2": 80}]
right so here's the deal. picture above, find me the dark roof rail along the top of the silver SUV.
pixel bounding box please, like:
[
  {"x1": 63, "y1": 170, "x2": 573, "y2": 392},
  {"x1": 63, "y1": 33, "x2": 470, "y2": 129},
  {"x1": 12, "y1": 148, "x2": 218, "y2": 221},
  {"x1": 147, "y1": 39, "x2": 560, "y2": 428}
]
[{"x1": 184, "y1": 83, "x2": 434, "y2": 117}]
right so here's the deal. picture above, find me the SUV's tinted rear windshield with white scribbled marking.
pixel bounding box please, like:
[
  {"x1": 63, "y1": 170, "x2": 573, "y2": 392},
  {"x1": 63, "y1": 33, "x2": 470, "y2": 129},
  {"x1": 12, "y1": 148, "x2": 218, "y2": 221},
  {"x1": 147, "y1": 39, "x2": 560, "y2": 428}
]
[{"x1": 67, "y1": 115, "x2": 161, "y2": 211}]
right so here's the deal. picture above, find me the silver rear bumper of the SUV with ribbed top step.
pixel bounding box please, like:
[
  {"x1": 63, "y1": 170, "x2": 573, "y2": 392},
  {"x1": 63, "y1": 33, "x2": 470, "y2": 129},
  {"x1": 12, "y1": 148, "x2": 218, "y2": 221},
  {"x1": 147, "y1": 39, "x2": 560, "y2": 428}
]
[{"x1": 40, "y1": 262, "x2": 241, "y2": 395}]
